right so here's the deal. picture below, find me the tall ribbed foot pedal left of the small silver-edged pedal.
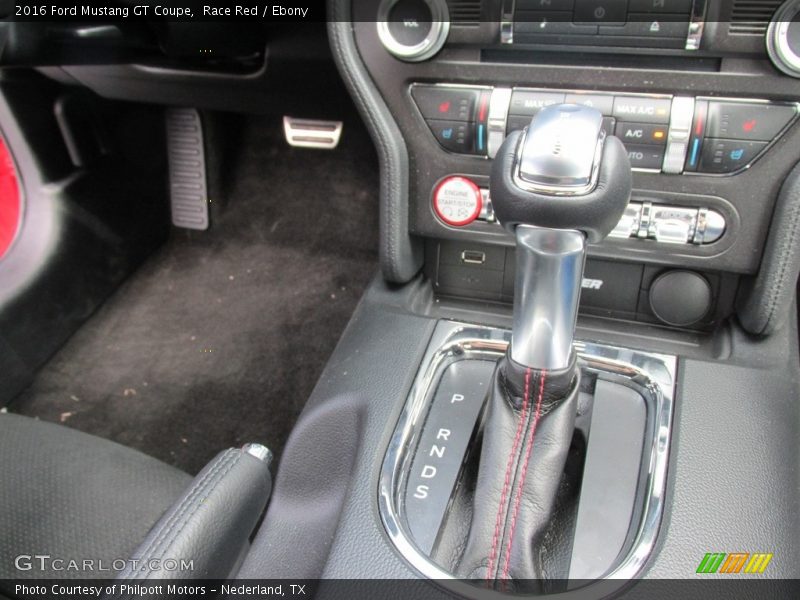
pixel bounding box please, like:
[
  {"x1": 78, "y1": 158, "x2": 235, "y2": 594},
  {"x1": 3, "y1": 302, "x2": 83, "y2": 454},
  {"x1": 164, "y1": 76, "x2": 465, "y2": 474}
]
[{"x1": 166, "y1": 108, "x2": 208, "y2": 230}]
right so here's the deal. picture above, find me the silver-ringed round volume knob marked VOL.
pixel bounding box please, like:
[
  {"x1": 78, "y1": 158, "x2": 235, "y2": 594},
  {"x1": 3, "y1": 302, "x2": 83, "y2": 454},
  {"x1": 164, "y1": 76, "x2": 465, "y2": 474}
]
[{"x1": 378, "y1": 0, "x2": 450, "y2": 62}]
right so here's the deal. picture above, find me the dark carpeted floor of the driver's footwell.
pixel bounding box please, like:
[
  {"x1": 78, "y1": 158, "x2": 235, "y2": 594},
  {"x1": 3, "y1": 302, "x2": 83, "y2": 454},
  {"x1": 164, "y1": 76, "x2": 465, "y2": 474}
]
[{"x1": 12, "y1": 112, "x2": 378, "y2": 473}]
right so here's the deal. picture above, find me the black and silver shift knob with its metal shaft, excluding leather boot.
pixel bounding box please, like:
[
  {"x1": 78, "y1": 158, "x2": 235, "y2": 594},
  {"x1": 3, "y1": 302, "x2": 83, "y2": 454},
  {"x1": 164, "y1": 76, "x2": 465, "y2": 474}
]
[{"x1": 491, "y1": 104, "x2": 631, "y2": 369}]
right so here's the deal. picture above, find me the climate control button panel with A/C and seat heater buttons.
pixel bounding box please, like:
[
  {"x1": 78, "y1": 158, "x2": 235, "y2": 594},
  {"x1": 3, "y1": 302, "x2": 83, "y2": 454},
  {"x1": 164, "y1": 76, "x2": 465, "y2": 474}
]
[{"x1": 411, "y1": 84, "x2": 798, "y2": 174}]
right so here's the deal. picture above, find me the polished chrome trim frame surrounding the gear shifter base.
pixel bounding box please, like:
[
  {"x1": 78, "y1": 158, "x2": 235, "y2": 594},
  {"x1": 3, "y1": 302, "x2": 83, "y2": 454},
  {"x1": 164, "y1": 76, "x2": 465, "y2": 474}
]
[{"x1": 378, "y1": 321, "x2": 677, "y2": 600}]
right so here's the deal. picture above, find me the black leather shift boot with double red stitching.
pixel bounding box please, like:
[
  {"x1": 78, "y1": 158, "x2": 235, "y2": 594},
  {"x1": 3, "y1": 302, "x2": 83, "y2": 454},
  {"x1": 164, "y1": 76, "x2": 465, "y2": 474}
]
[{"x1": 458, "y1": 355, "x2": 579, "y2": 591}]
